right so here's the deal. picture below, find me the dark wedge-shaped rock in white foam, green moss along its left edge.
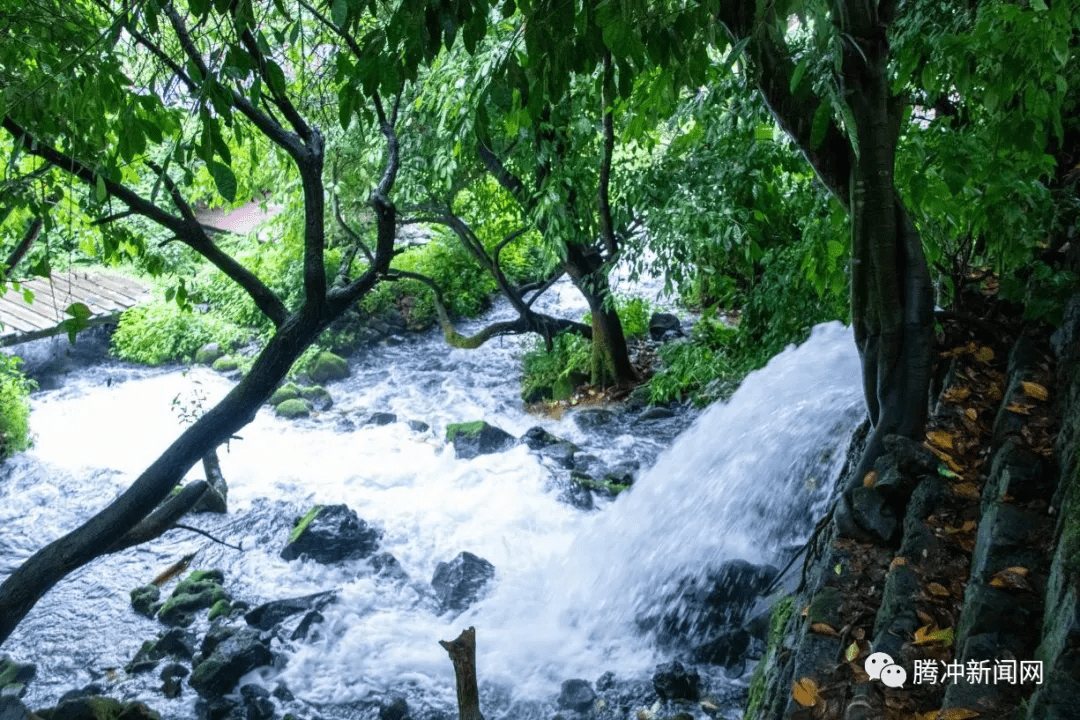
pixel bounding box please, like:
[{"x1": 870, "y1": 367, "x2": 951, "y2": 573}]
[{"x1": 281, "y1": 505, "x2": 382, "y2": 565}]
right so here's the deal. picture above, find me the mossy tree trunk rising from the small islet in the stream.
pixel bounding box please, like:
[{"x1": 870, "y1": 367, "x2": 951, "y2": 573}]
[{"x1": 565, "y1": 243, "x2": 638, "y2": 388}]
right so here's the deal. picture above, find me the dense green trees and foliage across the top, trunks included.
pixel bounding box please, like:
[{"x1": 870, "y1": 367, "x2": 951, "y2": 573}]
[{"x1": 0, "y1": 0, "x2": 1080, "y2": 641}]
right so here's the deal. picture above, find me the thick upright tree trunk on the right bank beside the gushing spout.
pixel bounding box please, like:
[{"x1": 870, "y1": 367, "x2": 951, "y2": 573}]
[{"x1": 842, "y1": 2, "x2": 933, "y2": 485}]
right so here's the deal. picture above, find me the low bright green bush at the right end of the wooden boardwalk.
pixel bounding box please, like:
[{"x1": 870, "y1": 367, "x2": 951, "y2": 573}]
[{"x1": 112, "y1": 301, "x2": 242, "y2": 365}]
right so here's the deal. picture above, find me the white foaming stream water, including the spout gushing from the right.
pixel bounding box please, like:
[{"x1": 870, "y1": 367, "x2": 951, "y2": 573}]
[{"x1": 0, "y1": 289, "x2": 863, "y2": 719}]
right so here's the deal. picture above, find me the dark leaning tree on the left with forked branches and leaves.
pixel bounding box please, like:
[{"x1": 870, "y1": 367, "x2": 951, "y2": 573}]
[{"x1": 0, "y1": 0, "x2": 406, "y2": 642}]
